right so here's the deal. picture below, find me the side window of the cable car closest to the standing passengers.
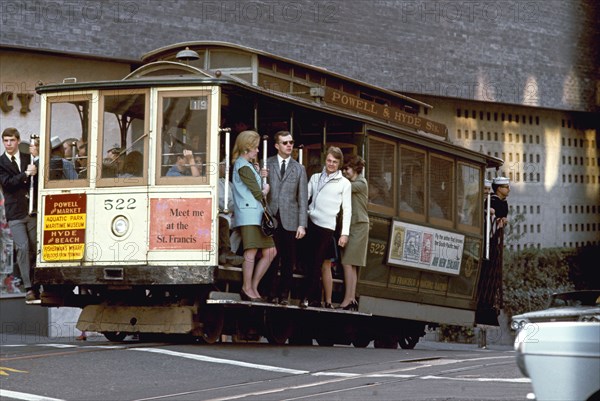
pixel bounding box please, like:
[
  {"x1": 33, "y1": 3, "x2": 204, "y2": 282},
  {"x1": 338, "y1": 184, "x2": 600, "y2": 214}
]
[{"x1": 367, "y1": 137, "x2": 397, "y2": 212}]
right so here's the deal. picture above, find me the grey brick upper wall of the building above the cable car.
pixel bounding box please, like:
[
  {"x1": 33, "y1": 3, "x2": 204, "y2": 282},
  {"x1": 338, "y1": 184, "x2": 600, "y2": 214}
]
[{"x1": 0, "y1": 0, "x2": 600, "y2": 111}]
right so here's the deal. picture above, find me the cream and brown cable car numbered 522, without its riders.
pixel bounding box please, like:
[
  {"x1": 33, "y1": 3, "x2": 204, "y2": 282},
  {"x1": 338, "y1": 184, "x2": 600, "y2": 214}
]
[{"x1": 35, "y1": 42, "x2": 501, "y2": 348}]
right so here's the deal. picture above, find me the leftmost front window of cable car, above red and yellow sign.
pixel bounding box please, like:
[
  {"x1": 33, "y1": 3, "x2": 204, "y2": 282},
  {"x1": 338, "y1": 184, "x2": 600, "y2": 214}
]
[{"x1": 45, "y1": 97, "x2": 90, "y2": 186}]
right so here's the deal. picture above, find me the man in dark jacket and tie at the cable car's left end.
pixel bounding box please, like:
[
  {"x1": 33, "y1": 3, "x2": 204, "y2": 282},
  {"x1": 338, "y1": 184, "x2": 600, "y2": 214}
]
[{"x1": 0, "y1": 128, "x2": 38, "y2": 301}]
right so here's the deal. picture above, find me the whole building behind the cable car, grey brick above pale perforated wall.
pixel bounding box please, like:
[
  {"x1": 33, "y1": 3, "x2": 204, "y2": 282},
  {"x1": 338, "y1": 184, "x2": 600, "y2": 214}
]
[{"x1": 0, "y1": 0, "x2": 600, "y2": 250}]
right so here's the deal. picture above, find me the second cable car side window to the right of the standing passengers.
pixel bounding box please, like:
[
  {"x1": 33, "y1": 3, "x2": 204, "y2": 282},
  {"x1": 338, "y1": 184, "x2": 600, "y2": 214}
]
[{"x1": 400, "y1": 146, "x2": 425, "y2": 215}]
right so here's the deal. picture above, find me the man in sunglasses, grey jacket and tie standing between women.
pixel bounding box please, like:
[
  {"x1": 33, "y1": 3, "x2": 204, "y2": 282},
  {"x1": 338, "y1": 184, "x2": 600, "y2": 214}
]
[{"x1": 267, "y1": 131, "x2": 308, "y2": 305}]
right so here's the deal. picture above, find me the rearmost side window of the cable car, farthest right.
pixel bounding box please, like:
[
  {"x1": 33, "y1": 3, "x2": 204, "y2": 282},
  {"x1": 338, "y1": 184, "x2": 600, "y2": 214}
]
[{"x1": 456, "y1": 163, "x2": 483, "y2": 227}]
